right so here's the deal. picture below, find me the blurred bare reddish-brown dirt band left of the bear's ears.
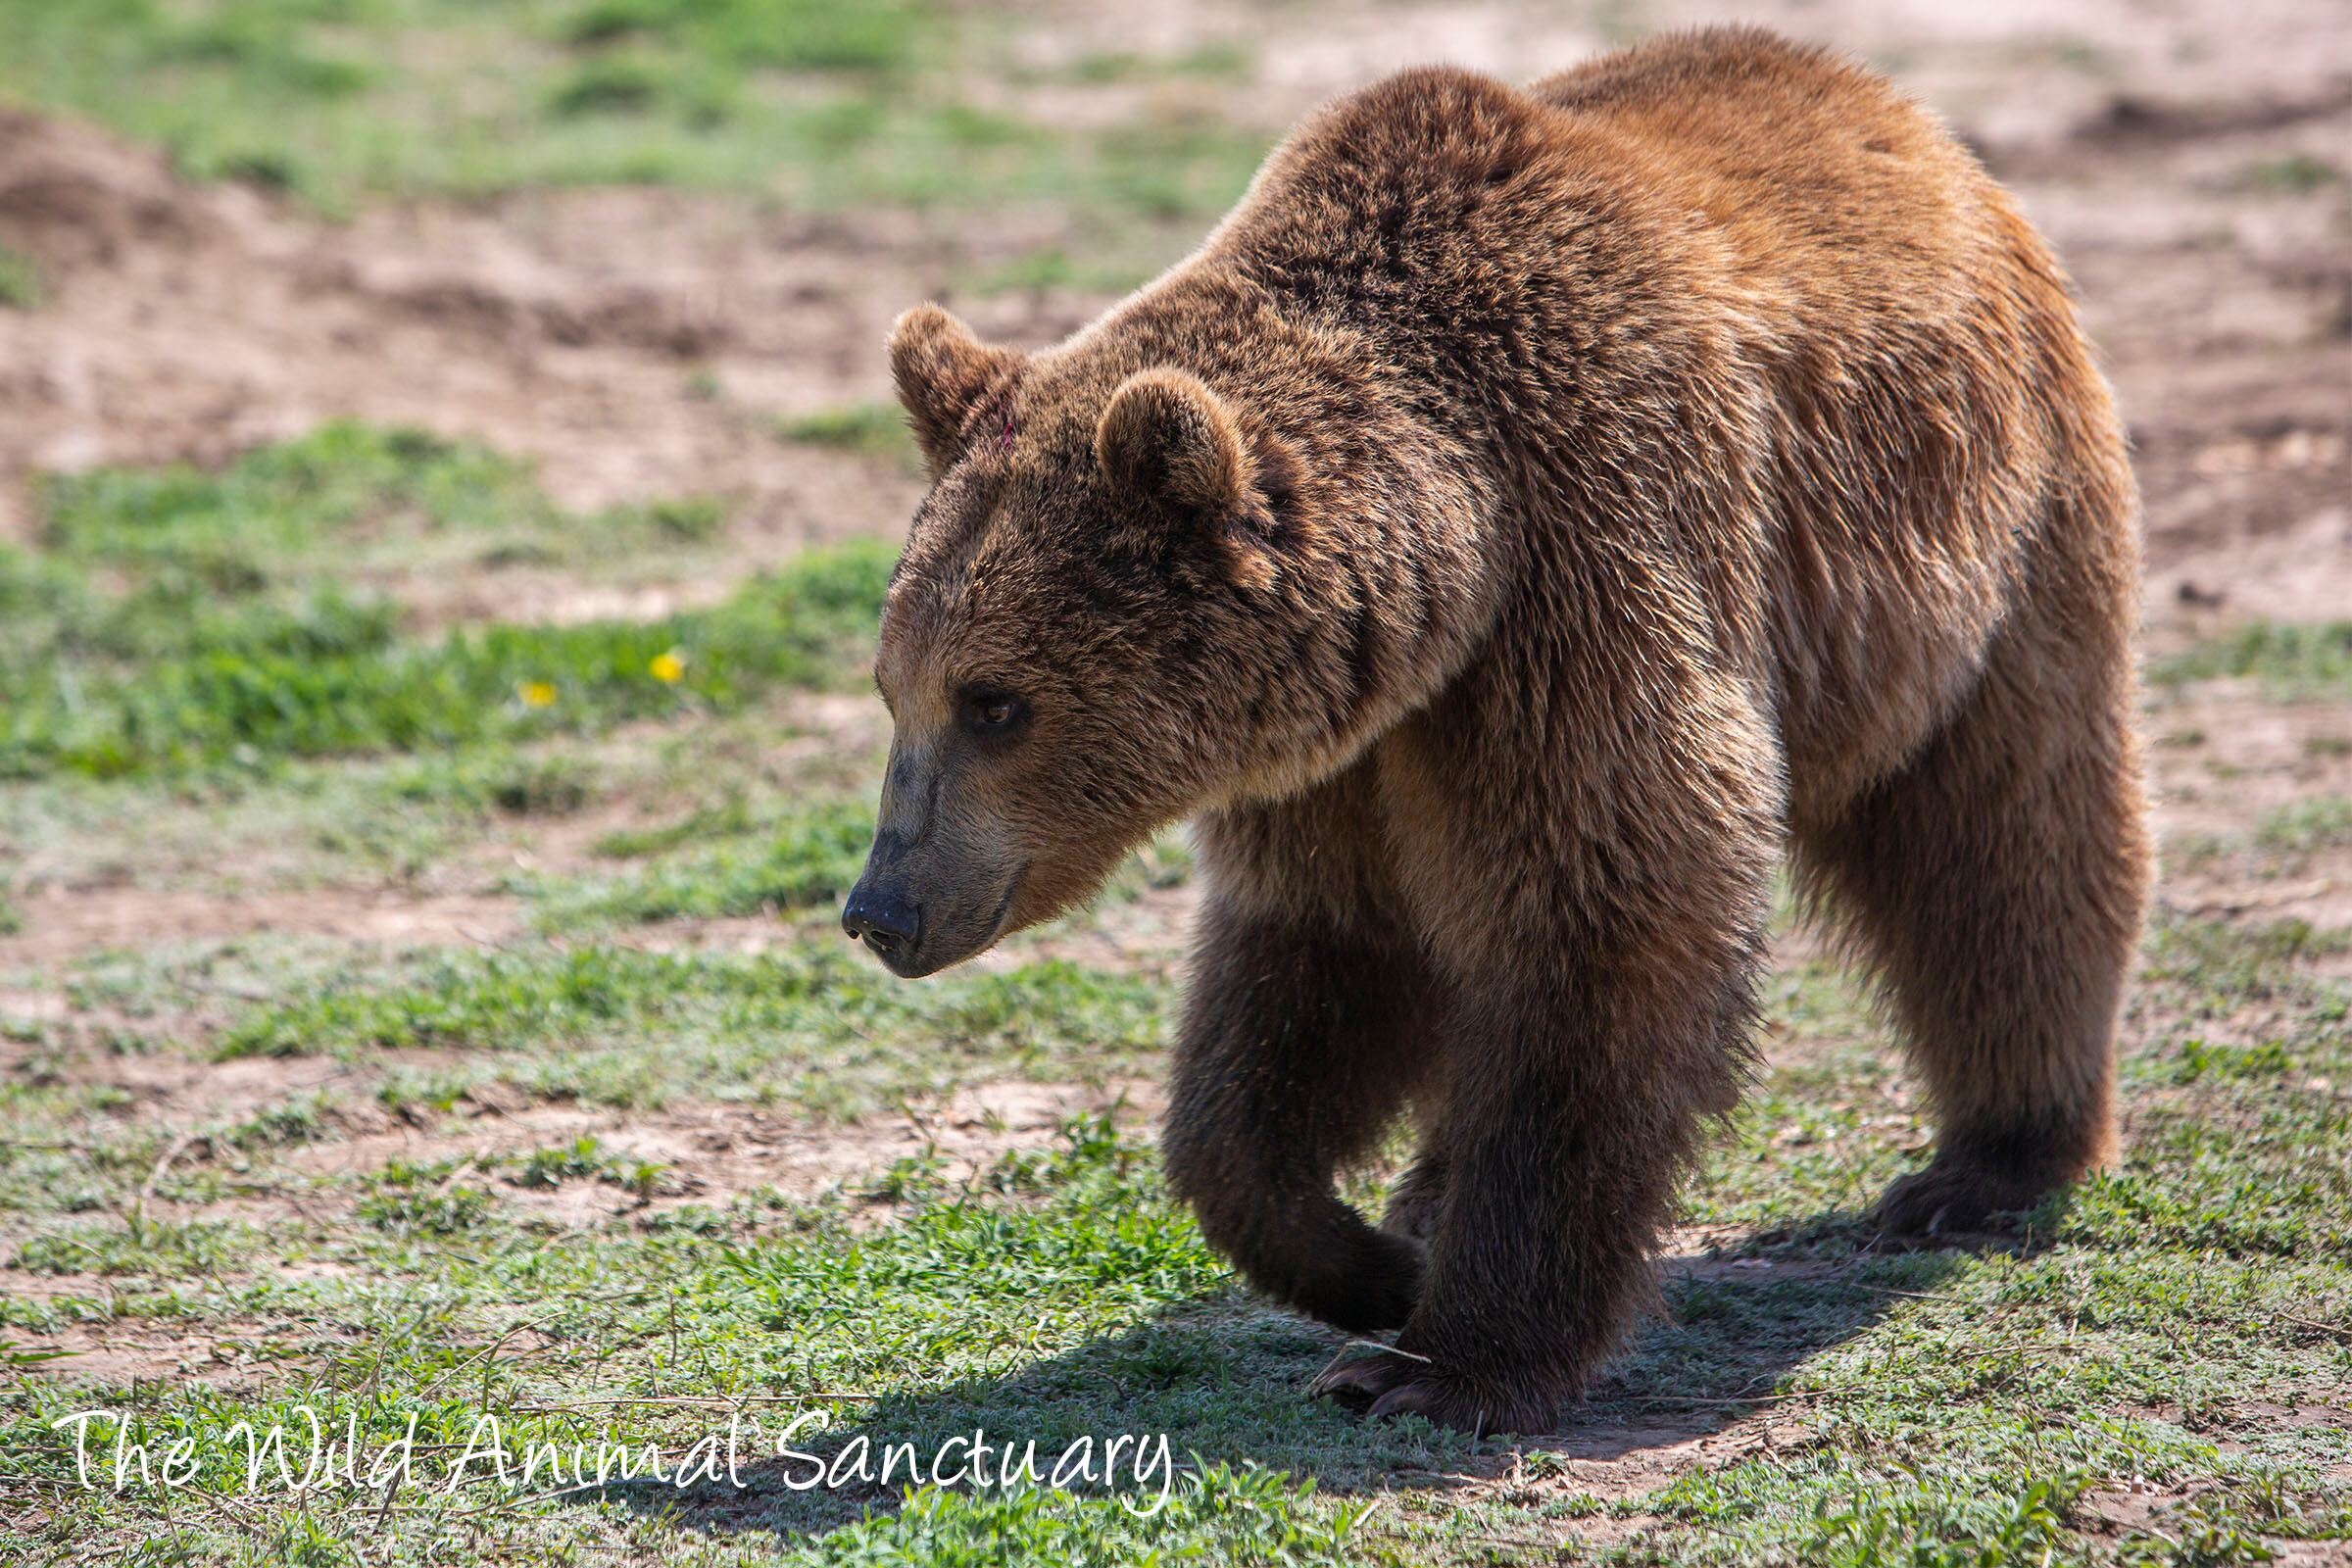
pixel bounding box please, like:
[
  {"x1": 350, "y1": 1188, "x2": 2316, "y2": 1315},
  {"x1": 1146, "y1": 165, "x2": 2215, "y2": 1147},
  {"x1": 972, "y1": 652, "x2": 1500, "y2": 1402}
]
[{"x1": 0, "y1": 113, "x2": 1080, "y2": 566}]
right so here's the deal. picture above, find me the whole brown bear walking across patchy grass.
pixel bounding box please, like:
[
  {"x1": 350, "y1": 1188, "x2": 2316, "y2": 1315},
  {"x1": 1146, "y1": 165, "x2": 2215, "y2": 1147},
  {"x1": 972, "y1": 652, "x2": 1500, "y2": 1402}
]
[{"x1": 845, "y1": 30, "x2": 2150, "y2": 1432}]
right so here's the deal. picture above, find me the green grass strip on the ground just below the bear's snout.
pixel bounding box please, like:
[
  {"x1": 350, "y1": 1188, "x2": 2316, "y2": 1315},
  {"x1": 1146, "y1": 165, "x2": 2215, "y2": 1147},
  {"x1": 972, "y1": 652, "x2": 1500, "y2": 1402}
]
[{"x1": 207, "y1": 941, "x2": 1166, "y2": 1116}]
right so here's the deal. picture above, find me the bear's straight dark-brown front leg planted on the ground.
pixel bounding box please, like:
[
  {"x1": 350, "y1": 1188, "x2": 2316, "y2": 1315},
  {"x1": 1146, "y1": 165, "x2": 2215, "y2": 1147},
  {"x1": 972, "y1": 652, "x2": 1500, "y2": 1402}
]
[{"x1": 1315, "y1": 955, "x2": 1747, "y2": 1432}]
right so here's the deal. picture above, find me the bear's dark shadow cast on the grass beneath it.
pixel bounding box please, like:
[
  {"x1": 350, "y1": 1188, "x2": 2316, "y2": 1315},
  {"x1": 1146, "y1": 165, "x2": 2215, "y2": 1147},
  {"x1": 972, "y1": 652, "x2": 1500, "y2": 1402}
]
[{"x1": 583, "y1": 1215, "x2": 1959, "y2": 1544}]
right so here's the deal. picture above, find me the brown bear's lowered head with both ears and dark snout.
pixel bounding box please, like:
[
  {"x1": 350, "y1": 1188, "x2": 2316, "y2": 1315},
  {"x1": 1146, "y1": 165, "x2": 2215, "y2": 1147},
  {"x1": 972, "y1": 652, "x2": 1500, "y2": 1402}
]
[{"x1": 845, "y1": 306, "x2": 1371, "y2": 976}]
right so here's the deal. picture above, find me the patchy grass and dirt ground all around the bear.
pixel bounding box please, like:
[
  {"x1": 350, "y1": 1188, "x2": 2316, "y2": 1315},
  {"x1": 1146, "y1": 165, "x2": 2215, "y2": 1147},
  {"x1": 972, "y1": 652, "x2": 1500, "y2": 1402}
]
[{"x1": 0, "y1": 0, "x2": 2352, "y2": 1563}]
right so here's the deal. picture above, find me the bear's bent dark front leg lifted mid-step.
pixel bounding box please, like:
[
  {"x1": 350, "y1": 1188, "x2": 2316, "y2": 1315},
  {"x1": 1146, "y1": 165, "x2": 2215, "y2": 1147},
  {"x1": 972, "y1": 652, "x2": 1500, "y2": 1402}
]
[{"x1": 1164, "y1": 903, "x2": 1435, "y2": 1333}]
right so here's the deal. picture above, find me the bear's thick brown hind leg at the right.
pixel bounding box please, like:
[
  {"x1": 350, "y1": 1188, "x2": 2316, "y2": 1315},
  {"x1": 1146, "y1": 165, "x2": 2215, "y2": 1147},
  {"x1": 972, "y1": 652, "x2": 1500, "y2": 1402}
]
[{"x1": 1797, "y1": 521, "x2": 2150, "y2": 1234}]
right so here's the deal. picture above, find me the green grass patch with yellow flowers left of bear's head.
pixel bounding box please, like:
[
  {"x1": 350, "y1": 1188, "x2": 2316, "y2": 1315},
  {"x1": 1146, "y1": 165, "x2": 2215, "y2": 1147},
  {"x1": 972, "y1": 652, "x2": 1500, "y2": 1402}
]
[{"x1": 0, "y1": 425, "x2": 889, "y2": 776}]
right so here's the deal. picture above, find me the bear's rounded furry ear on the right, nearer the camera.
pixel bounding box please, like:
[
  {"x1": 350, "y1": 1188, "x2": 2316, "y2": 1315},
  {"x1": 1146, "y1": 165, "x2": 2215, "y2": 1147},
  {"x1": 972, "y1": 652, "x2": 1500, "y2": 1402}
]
[{"x1": 1094, "y1": 369, "x2": 1275, "y2": 588}]
